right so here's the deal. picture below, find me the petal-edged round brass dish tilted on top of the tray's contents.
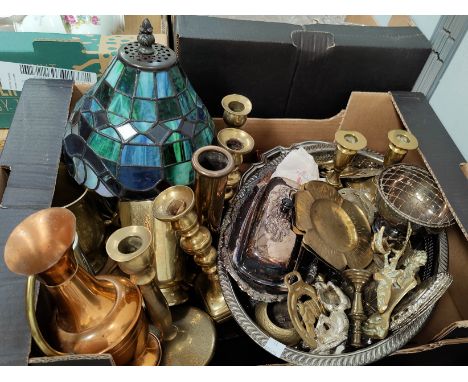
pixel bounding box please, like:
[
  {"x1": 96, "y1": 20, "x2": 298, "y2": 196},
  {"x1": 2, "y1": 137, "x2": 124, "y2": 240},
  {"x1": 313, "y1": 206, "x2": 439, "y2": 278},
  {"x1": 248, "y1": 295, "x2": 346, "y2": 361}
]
[{"x1": 294, "y1": 181, "x2": 372, "y2": 270}]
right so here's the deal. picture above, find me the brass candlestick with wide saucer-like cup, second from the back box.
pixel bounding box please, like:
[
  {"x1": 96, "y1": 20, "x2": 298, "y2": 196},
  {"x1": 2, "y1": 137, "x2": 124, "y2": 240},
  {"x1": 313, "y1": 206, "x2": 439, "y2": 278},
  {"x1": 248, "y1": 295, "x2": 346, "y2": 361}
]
[{"x1": 217, "y1": 127, "x2": 255, "y2": 200}]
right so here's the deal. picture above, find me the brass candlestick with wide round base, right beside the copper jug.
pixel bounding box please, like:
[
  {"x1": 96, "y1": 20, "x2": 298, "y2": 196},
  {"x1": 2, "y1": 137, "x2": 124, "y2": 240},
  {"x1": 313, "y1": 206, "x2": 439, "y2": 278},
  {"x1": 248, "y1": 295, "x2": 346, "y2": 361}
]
[{"x1": 106, "y1": 226, "x2": 216, "y2": 366}]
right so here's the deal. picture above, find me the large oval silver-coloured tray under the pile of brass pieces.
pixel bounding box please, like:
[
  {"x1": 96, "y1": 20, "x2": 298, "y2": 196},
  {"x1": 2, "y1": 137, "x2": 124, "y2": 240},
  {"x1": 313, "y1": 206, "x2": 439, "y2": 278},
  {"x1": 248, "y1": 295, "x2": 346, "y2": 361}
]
[{"x1": 218, "y1": 141, "x2": 448, "y2": 366}]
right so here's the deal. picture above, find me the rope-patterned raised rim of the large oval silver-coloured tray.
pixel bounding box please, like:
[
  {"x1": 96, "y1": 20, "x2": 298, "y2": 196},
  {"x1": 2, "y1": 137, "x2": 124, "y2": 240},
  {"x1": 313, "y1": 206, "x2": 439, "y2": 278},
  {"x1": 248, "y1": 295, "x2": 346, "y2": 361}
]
[{"x1": 218, "y1": 141, "x2": 448, "y2": 366}]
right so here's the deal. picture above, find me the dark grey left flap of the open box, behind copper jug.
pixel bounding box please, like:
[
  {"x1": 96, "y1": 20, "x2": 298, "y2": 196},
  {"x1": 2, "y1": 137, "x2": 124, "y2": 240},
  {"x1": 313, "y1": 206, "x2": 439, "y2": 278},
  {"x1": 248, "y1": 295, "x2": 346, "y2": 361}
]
[{"x1": 0, "y1": 79, "x2": 73, "y2": 365}]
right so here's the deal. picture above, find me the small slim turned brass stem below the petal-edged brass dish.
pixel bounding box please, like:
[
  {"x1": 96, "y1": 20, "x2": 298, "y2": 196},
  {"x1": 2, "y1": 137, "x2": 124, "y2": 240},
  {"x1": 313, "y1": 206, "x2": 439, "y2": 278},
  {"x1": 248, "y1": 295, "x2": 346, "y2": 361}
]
[{"x1": 343, "y1": 269, "x2": 372, "y2": 348}]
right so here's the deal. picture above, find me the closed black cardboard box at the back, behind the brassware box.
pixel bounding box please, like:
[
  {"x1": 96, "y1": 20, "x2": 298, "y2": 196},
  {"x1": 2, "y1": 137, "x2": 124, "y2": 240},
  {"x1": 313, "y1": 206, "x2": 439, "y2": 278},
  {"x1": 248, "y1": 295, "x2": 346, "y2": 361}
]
[{"x1": 171, "y1": 16, "x2": 431, "y2": 119}]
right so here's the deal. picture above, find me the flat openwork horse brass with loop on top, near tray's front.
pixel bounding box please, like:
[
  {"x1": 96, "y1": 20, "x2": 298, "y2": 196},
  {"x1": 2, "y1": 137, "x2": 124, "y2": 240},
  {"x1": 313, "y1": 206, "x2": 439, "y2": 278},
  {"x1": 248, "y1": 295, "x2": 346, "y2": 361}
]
[{"x1": 284, "y1": 271, "x2": 325, "y2": 349}]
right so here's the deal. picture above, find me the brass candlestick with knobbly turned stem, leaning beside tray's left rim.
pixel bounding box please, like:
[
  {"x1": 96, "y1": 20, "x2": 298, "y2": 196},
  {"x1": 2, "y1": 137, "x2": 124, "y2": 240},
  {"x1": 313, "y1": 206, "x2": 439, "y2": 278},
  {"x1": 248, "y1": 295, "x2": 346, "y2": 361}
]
[{"x1": 153, "y1": 186, "x2": 231, "y2": 322}]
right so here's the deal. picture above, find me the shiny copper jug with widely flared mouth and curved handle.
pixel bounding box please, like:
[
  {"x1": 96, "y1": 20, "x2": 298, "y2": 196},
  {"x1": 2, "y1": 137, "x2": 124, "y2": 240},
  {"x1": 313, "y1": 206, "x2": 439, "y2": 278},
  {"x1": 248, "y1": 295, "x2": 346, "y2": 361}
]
[{"x1": 5, "y1": 208, "x2": 161, "y2": 365}]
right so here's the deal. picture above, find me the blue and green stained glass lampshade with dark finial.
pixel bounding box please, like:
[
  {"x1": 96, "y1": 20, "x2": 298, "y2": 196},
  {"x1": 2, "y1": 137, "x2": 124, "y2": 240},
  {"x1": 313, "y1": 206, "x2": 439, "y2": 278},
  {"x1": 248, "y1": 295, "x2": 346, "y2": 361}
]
[{"x1": 64, "y1": 20, "x2": 214, "y2": 200}]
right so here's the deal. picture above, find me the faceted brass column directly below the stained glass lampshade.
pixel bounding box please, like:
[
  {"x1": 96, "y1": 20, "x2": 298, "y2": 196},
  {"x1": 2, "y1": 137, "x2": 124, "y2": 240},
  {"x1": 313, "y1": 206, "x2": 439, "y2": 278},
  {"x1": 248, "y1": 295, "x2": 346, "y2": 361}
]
[{"x1": 119, "y1": 200, "x2": 188, "y2": 306}]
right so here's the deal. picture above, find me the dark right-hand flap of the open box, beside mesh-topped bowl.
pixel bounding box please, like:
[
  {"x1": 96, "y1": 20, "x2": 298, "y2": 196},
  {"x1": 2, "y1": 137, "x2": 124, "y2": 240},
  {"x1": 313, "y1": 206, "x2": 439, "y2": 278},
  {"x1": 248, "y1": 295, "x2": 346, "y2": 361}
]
[{"x1": 392, "y1": 92, "x2": 468, "y2": 240}]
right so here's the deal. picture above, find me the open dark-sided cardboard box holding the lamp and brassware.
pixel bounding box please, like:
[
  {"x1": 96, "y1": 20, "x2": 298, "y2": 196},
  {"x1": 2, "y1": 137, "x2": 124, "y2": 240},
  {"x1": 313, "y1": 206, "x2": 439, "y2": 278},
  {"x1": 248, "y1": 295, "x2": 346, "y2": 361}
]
[{"x1": 0, "y1": 74, "x2": 468, "y2": 365}]
